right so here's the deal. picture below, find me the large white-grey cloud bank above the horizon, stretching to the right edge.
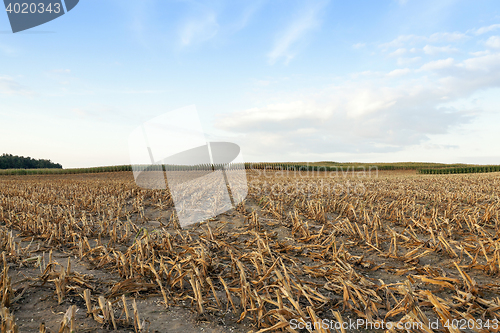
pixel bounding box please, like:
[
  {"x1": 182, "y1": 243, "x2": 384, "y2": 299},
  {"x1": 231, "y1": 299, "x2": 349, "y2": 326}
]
[{"x1": 216, "y1": 49, "x2": 500, "y2": 156}]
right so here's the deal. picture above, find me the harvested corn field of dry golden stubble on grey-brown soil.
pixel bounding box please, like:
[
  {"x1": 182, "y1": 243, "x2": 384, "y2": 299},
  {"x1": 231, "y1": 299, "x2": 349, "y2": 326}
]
[{"x1": 0, "y1": 170, "x2": 500, "y2": 332}]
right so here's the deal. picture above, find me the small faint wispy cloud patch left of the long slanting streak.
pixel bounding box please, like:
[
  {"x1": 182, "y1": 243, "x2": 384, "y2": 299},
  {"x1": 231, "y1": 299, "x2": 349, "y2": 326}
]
[{"x1": 179, "y1": 12, "x2": 219, "y2": 46}]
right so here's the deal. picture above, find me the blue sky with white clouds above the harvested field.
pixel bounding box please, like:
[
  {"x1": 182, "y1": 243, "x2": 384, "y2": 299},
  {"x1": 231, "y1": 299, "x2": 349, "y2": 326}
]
[{"x1": 0, "y1": 0, "x2": 500, "y2": 168}]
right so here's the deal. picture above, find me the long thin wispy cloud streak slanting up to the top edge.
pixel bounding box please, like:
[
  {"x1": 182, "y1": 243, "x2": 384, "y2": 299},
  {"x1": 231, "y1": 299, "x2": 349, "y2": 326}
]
[{"x1": 268, "y1": 1, "x2": 328, "y2": 64}]
